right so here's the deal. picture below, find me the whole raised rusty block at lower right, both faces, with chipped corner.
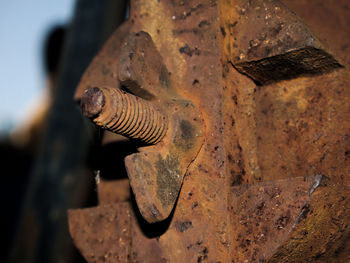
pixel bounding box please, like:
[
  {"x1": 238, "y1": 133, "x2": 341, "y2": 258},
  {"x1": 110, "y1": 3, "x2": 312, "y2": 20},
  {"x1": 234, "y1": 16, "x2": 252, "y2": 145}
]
[{"x1": 230, "y1": 175, "x2": 350, "y2": 262}]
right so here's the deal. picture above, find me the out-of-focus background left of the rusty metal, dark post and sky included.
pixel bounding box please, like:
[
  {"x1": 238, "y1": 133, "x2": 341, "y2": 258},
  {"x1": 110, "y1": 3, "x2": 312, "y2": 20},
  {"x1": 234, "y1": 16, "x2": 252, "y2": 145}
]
[{"x1": 0, "y1": 0, "x2": 128, "y2": 262}]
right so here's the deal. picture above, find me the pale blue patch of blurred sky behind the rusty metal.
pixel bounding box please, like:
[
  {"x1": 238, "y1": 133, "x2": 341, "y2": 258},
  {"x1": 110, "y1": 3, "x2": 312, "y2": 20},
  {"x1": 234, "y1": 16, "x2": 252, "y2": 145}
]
[{"x1": 0, "y1": 0, "x2": 75, "y2": 131}]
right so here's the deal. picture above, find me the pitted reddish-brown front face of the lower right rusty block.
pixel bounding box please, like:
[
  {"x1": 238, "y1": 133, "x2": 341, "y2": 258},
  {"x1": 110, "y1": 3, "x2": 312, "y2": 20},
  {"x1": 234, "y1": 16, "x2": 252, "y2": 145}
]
[{"x1": 230, "y1": 177, "x2": 317, "y2": 262}]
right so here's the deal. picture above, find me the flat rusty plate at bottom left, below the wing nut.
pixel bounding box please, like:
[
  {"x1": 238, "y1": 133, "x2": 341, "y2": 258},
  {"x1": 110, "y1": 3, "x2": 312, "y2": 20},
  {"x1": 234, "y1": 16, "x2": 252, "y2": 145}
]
[{"x1": 68, "y1": 203, "x2": 131, "y2": 262}]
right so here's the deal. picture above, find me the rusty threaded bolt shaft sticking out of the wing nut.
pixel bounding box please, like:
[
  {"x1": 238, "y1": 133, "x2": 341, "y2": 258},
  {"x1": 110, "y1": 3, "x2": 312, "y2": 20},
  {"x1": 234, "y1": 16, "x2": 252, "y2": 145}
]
[{"x1": 81, "y1": 87, "x2": 168, "y2": 144}]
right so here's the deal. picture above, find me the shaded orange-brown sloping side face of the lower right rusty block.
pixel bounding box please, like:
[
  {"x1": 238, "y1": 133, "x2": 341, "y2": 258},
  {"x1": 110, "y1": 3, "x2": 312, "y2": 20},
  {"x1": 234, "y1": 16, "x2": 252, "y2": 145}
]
[{"x1": 268, "y1": 181, "x2": 350, "y2": 263}]
